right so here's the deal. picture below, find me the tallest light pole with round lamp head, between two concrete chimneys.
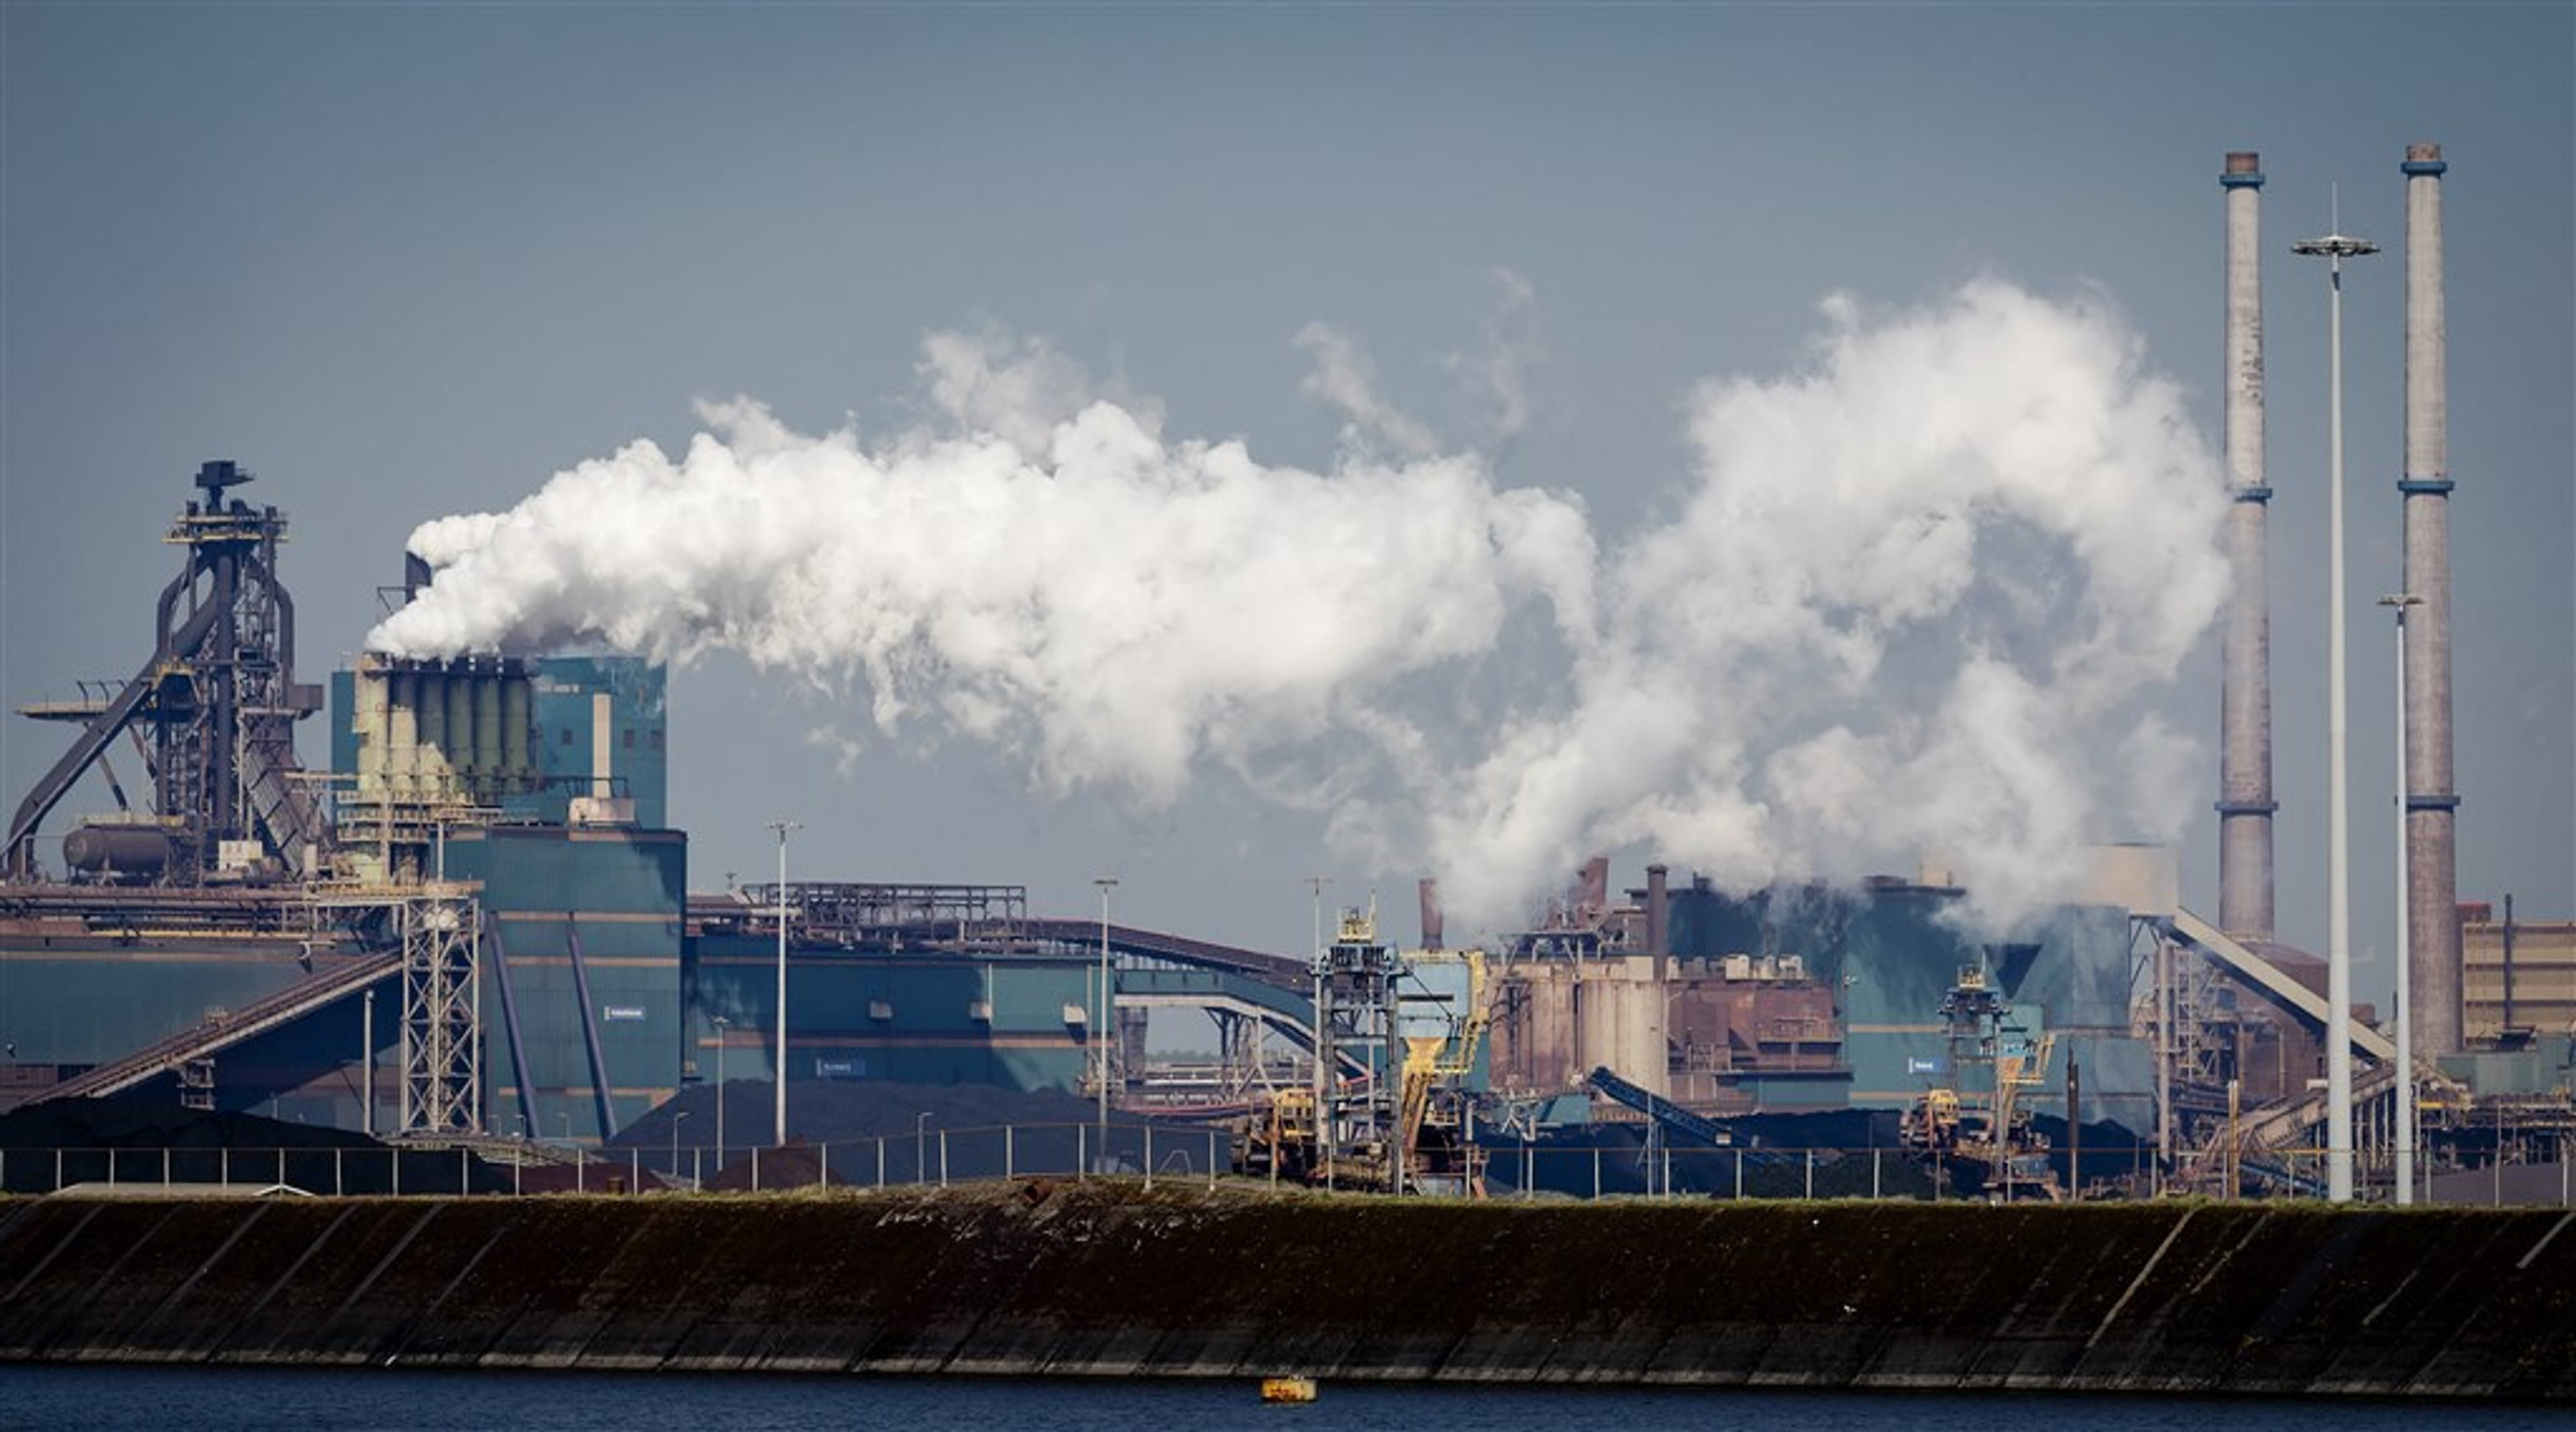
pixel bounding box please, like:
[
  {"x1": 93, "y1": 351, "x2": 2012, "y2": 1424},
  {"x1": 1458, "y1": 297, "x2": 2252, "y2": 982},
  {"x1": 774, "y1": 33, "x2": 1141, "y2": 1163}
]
[{"x1": 2290, "y1": 209, "x2": 2380, "y2": 1203}]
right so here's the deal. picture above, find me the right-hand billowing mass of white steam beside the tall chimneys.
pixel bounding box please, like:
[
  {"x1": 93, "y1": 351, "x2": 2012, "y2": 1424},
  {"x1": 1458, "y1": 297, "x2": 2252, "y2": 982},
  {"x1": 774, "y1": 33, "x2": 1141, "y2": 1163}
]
[{"x1": 1430, "y1": 280, "x2": 2229, "y2": 919}]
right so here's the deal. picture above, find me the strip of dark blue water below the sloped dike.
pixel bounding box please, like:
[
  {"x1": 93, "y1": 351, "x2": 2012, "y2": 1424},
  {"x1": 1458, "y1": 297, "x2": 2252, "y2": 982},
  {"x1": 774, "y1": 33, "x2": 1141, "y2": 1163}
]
[{"x1": 0, "y1": 1365, "x2": 2544, "y2": 1432}]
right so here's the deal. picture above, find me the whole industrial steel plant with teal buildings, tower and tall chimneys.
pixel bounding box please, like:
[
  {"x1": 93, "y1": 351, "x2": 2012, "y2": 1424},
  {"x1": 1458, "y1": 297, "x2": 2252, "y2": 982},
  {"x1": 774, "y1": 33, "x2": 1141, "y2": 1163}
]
[{"x1": 0, "y1": 144, "x2": 2576, "y2": 1200}]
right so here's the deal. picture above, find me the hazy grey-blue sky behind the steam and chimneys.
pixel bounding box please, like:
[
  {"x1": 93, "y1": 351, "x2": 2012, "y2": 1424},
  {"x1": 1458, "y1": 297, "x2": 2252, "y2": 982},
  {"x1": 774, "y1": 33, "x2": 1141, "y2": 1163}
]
[{"x1": 0, "y1": 5, "x2": 2576, "y2": 996}]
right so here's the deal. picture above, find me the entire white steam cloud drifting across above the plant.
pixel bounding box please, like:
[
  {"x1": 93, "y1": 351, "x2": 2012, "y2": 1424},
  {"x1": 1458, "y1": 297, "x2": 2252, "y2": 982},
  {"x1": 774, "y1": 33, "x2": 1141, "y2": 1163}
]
[{"x1": 368, "y1": 280, "x2": 2229, "y2": 925}]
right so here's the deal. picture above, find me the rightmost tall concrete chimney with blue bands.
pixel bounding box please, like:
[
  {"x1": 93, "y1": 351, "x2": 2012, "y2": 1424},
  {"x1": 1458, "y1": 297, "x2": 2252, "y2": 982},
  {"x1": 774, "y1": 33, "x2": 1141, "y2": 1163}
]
[{"x1": 2398, "y1": 144, "x2": 2463, "y2": 1058}]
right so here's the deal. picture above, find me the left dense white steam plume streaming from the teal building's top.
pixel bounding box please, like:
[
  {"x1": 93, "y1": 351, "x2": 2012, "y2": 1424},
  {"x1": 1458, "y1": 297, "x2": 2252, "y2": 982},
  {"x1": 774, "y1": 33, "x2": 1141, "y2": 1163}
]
[{"x1": 368, "y1": 335, "x2": 1595, "y2": 806}]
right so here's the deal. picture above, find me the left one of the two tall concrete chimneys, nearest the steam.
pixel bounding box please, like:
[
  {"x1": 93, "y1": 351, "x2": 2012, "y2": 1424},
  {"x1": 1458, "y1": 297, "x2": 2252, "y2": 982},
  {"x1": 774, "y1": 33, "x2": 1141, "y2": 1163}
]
[{"x1": 2218, "y1": 152, "x2": 2279, "y2": 940}]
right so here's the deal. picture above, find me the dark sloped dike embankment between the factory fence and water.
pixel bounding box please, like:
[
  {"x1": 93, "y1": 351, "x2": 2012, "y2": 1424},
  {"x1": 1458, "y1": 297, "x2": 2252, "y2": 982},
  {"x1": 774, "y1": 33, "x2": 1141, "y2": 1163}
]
[{"x1": 0, "y1": 1182, "x2": 2576, "y2": 1401}]
